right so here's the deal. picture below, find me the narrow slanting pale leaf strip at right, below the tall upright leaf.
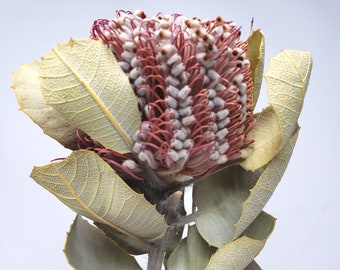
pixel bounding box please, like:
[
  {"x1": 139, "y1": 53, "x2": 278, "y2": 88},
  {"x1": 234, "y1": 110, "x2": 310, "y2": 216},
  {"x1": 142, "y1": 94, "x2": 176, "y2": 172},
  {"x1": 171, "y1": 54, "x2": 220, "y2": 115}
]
[{"x1": 235, "y1": 129, "x2": 299, "y2": 236}]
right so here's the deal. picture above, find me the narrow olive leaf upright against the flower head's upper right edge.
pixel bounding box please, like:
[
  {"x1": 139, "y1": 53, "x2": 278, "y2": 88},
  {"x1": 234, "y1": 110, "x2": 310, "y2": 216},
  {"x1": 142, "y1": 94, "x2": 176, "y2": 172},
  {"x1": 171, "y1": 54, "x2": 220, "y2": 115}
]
[{"x1": 247, "y1": 29, "x2": 265, "y2": 105}]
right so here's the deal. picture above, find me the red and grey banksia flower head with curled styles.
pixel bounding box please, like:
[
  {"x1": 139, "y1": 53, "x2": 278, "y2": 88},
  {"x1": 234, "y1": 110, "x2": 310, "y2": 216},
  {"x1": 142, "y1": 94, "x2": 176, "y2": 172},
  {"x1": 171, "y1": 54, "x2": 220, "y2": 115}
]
[{"x1": 83, "y1": 11, "x2": 255, "y2": 187}]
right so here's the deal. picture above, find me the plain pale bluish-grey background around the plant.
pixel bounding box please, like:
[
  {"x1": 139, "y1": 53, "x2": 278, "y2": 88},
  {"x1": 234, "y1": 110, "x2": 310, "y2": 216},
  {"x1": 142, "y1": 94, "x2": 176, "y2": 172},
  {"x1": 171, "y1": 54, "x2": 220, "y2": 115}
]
[{"x1": 0, "y1": 0, "x2": 340, "y2": 270}]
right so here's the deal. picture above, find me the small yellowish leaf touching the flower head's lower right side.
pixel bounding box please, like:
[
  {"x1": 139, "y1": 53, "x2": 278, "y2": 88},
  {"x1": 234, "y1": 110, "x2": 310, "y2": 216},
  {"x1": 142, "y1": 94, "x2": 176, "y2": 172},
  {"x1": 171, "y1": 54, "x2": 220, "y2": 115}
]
[{"x1": 241, "y1": 105, "x2": 282, "y2": 171}]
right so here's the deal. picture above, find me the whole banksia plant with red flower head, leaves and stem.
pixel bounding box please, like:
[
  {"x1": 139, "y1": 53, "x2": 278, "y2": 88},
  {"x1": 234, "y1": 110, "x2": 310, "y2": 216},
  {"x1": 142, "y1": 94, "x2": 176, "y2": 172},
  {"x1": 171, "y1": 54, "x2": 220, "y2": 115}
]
[{"x1": 12, "y1": 11, "x2": 312, "y2": 270}]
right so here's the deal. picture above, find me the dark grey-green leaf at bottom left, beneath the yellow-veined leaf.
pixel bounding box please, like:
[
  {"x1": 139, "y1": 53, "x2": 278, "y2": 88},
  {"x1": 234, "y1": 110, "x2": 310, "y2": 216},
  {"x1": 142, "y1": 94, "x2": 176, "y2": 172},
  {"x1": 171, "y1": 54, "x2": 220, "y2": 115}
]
[{"x1": 64, "y1": 215, "x2": 142, "y2": 270}]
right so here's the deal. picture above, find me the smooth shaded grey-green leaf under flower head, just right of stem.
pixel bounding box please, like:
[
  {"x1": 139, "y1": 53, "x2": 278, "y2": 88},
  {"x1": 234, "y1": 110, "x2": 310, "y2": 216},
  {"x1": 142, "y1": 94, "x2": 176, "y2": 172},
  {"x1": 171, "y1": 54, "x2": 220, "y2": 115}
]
[{"x1": 193, "y1": 166, "x2": 257, "y2": 247}]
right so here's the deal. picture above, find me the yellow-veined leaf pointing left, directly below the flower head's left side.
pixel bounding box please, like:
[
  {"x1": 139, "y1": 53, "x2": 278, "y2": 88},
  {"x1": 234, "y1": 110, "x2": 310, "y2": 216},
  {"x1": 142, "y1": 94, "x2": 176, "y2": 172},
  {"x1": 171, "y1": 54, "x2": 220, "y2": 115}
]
[{"x1": 31, "y1": 150, "x2": 167, "y2": 242}]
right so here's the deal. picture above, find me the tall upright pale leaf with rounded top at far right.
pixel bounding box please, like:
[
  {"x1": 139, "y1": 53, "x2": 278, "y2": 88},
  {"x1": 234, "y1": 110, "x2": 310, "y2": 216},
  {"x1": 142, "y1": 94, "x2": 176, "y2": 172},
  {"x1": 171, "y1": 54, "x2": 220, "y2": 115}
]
[{"x1": 265, "y1": 50, "x2": 312, "y2": 148}]
